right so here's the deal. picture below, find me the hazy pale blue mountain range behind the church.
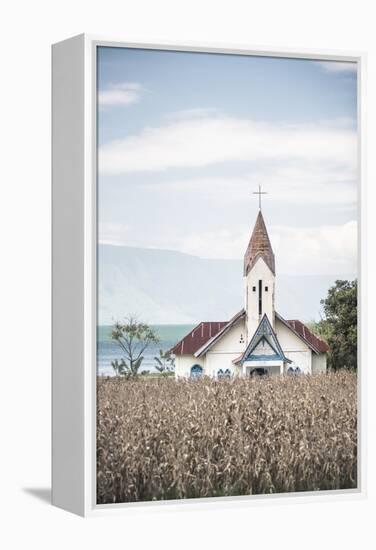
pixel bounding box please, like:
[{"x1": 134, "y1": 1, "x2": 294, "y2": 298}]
[{"x1": 98, "y1": 244, "x2": 352, "y2": 325}]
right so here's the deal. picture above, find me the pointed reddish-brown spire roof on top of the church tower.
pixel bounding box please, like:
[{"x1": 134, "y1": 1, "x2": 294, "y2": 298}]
[{"x1": 244, "y1": 210, "x2": 275, "y2": 275}]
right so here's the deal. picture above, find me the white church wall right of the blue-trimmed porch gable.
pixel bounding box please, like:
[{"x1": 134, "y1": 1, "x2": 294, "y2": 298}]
[{"x1": 275, "y1": 319, "x2": 313, "y2": 374}]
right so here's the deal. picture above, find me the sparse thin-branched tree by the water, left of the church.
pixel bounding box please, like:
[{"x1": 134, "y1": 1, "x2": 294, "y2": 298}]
[{"x1": 111, "y1": 317, "x2": 159, "y2": 378}]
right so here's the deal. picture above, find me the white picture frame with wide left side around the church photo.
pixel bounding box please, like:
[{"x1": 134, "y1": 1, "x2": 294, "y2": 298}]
[{"x1": 52, "y1": 34, "x2": 366, "y2": 516}]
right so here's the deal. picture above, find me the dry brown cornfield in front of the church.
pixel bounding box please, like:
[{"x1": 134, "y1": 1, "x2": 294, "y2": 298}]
[{"x1": 97, "y1": 372, "x2": 357, "y2": 503}]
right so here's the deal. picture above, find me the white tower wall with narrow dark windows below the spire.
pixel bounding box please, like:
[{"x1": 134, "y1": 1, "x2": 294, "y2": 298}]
[{"x1": 245, "y1": 258, "x2": 275, "y2": 342}]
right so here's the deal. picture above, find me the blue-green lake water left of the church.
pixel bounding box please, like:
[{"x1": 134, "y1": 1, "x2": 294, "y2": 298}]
[{"x1": 97, "y1": 325, "x2": 195, "y2": 376}]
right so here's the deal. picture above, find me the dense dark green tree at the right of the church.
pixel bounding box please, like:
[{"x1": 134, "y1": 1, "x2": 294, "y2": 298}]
[{"x1": 315, "y1": 279, "x2": 358, "y2": 370}]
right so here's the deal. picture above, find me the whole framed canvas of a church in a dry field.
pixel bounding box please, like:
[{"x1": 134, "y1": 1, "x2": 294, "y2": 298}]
[{"x1": 52, "y1": 35, "x2": 366, "y2": 516}]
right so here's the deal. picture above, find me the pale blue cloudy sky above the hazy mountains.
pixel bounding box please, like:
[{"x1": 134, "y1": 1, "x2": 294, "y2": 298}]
[{"x1": 98, "y1": 47, "x2": 358, "y2": 276}]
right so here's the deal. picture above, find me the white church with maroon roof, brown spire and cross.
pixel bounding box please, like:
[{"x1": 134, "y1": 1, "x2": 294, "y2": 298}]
[{"x1": 171, "y1": 194, "x2": 328, "y2": 378}]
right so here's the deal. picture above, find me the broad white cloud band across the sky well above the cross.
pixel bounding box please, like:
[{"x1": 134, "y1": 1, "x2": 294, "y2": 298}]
[{"x1": 98, "y1": 115, "x2": 357, "y2": 174}]
